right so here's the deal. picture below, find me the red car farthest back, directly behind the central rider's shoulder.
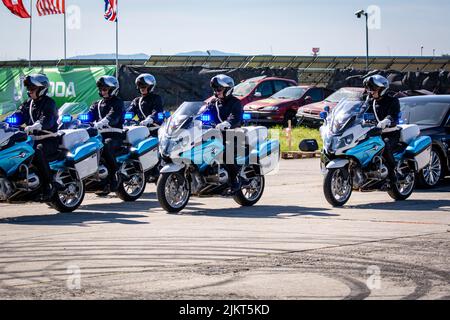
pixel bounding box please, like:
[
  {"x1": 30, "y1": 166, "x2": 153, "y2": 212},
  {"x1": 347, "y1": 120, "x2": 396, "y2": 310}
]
[{"x1": 206, "y1": 76, "x2": 297, "y2": 106}]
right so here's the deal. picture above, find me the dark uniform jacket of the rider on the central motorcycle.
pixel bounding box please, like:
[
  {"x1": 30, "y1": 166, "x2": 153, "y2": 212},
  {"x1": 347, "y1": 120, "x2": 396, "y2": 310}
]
[{"x1": 207, "y1": 95, "x2": 243, "y2": 129}]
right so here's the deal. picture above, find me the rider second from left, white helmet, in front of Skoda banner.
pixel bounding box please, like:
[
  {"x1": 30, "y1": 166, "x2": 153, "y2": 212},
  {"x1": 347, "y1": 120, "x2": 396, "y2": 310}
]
[{"x1": 89, "y1": 76, "x2": 124, "y2": 191}]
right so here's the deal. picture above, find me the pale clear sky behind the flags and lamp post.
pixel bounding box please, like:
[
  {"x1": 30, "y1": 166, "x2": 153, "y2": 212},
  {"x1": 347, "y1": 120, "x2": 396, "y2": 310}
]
[{"x1": 0, "y1": 0, "x2": 450, "y2": 60}]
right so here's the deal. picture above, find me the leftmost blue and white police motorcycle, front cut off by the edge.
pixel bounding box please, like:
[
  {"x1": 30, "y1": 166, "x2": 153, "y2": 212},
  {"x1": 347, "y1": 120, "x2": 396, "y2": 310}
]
[{"x1": 0, "y1": 115, "x2": 101, "y2": 212}]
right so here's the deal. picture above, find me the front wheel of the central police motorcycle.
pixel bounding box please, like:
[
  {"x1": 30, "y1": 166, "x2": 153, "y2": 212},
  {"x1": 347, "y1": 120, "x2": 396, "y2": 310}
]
[{"x1": 156, "y1": 172, "x2": 191, "y2": 213}]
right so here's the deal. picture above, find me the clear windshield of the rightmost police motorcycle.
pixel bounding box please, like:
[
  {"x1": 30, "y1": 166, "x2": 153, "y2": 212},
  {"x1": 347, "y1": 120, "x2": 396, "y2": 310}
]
[{"x1": 328, "y1": 100, "x2": 365, "y2": 135}]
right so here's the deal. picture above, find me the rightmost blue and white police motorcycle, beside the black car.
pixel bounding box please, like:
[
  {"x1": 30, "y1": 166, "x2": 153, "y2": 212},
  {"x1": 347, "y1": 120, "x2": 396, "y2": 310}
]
[{"x1": 320, "y1": 100, "x2": 431, "y2": 206}]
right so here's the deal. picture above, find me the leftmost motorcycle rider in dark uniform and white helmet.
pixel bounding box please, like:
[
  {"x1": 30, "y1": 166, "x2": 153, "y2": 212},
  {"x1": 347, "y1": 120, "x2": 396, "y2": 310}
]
[{"x1": 13, "y1": 74, "x2": 58, "y2": 201}]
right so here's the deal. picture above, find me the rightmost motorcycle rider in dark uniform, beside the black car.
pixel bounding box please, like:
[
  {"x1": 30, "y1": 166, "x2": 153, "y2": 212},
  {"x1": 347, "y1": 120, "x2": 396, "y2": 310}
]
[{"x1": 364, "y1": 75, "x2": 400, "y2": 182}]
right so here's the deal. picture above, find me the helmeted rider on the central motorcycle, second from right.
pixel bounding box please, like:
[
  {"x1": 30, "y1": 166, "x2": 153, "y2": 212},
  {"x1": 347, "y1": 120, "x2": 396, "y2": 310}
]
[{"x1": 206, "y1": 74, "x2": 243, "y2": 192}]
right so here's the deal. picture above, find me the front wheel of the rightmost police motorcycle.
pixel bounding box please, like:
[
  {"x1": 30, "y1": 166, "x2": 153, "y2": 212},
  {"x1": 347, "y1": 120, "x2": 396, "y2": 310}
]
[{"x1": 323, "y1": 167, "x2": 353, "y2": 207}]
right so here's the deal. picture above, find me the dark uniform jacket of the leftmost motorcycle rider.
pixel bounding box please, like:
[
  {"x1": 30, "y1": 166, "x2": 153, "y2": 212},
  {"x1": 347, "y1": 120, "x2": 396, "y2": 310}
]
[{"x1": 14, "y1": 96, "x2": 58, "y2": 135}]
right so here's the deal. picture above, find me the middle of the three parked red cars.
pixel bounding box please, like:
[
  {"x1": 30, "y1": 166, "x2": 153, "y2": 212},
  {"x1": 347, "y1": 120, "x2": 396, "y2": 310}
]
[{"x1": 244, "y1": 86, "x2": 333, "y2": 126}]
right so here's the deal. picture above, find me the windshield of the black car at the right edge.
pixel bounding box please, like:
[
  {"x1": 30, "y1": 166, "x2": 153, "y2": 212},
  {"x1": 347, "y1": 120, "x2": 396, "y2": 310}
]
[{"x1": 400, "y1": 100, "x2": 450, "y2": 126}]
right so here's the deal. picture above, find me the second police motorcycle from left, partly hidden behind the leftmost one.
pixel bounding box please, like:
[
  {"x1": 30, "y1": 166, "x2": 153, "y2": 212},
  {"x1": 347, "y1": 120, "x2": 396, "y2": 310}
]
[{"x1": 59, "y1": 106, "x2": 159, "y2": 201}]
